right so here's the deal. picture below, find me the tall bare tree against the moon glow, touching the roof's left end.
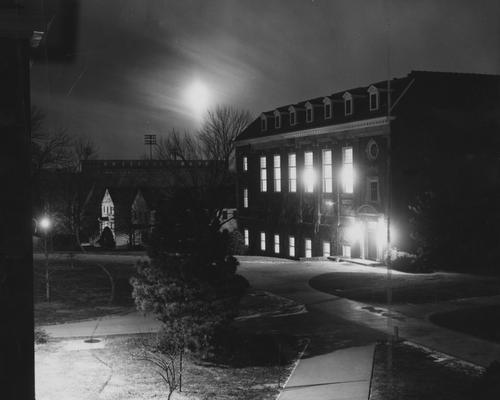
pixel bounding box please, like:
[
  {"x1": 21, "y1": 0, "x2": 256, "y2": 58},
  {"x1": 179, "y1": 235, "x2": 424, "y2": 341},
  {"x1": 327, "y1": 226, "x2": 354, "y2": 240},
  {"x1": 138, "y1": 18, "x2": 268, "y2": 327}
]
[{"x1": 200, "y1": 106, "x2": 252, "y2": 169}]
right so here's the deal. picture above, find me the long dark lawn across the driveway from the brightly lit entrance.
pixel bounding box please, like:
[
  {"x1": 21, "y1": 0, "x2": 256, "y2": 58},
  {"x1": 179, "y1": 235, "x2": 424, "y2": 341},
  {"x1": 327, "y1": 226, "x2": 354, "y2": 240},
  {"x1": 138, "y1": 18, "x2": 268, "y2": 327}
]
[{"x1": 309, "y1": 271, "x2": 500, "y2": 304}]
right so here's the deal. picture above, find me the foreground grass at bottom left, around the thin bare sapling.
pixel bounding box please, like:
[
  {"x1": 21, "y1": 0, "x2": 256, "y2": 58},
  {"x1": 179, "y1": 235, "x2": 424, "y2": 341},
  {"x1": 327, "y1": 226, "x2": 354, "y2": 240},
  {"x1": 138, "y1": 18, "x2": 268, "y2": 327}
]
[{"x1": 35, "y1": 336, "x2": 299, "y2": 400}]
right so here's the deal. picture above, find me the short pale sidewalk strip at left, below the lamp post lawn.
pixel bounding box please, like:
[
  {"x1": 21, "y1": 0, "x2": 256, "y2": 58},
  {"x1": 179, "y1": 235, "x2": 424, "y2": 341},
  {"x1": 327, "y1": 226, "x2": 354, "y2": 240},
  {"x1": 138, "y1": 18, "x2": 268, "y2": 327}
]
[{"x1": 40, "y1": 312, "x2": 161, "y2": 339}]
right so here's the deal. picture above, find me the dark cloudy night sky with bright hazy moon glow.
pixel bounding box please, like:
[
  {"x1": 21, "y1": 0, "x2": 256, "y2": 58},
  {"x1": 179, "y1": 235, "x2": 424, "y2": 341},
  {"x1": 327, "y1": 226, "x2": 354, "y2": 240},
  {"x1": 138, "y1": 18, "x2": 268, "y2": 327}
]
[{"x1": 32, "y1": 0, "x2": 500, "y2": 158}]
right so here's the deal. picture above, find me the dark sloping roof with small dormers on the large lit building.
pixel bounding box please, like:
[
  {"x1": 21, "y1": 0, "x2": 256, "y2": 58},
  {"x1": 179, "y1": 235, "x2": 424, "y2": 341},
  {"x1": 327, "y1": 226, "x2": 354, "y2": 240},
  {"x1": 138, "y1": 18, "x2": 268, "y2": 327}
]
[{"x1": 236, "y1": 71, "x2": 500, "y2": 142}]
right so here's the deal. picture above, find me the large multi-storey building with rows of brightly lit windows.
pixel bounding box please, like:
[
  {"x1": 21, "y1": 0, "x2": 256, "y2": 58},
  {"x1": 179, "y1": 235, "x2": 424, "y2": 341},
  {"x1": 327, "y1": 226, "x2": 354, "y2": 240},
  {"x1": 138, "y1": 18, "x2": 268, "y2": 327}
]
[{"x1": 236, "y1": 71, "x2": 500, "y2": 260}]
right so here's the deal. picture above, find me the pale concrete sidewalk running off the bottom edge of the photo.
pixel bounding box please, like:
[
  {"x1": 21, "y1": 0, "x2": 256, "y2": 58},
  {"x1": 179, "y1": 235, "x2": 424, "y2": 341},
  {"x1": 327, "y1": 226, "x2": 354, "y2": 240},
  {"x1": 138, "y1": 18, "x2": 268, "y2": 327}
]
[{"x1": 278, "y1": 344, "x2": 375, "y2": 400}]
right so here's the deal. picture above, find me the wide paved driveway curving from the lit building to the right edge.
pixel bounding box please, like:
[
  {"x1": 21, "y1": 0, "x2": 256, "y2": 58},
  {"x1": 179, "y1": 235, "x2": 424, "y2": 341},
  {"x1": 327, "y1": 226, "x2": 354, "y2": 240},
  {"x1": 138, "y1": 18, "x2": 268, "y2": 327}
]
[{"x1": 239, "y1": 258, "x2": 500, "y2": 366}]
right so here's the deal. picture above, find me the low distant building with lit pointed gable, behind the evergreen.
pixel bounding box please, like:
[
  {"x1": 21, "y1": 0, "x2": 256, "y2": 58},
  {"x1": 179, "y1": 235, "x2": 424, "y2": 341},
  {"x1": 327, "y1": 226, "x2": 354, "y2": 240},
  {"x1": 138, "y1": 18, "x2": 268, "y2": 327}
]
[{"x1": 82, "y1": 160, "x2": 236, "y2": 247}]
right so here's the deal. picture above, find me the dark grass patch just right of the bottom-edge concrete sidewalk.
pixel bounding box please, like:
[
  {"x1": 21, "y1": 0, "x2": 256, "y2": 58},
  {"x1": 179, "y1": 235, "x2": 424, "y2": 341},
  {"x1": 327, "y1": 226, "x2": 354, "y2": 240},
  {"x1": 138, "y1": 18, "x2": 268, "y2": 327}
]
[{"x1": 370, "y1": 343, "x2": 482, "y2": 400}]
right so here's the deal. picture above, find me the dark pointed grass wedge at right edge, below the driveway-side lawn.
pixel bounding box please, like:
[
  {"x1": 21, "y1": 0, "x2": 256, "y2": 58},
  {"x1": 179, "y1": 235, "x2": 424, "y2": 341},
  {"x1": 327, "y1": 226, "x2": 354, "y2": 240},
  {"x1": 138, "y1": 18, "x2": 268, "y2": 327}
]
[{"x1": 429, "y1": 305, "x2": 500, "y2": 343}]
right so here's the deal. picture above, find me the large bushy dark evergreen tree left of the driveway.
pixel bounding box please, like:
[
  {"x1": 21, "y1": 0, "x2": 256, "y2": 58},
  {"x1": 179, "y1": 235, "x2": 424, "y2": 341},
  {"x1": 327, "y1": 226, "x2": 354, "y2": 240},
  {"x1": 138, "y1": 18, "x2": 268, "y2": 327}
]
[{"x1": 131, "y1": 191, "x2": 248, "y2": 355}]
